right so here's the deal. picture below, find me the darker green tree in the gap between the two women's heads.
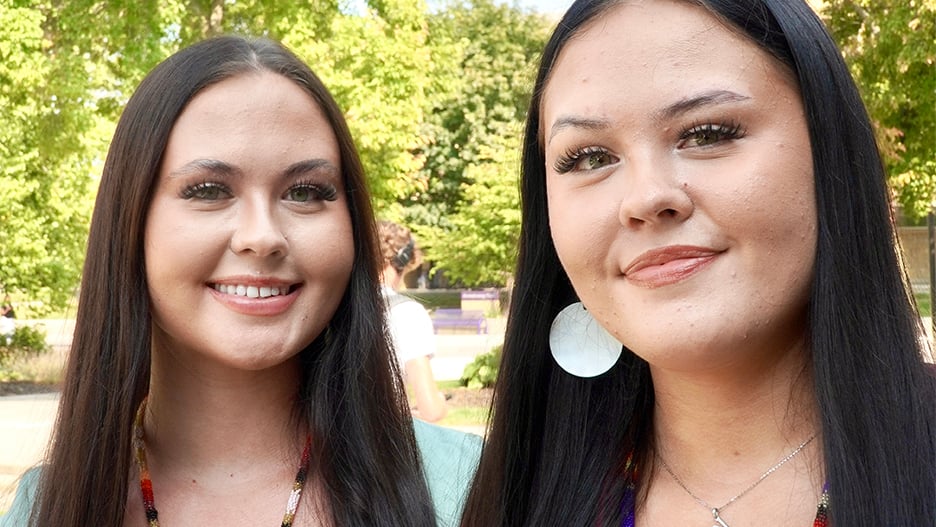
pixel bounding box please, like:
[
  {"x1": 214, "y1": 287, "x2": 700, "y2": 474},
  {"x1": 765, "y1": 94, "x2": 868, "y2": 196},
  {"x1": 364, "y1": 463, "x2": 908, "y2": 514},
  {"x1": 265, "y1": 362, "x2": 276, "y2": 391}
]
[{"x1": 404, "y1": 0, "x2": 551, "y2": 286}]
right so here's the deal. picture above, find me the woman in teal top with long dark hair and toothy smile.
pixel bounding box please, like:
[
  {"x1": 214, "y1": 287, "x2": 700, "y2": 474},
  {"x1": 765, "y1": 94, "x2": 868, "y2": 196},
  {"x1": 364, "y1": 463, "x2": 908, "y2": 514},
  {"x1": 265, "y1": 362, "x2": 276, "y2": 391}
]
[{"x1": 0, "y1": 37, "x2": 479, "y2": 527}]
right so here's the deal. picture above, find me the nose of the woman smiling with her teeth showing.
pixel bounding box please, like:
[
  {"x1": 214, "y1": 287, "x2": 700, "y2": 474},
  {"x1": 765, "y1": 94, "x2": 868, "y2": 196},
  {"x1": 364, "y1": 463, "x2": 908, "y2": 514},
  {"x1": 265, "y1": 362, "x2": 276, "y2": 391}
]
[{"x1": 230, "y1": 200, "x2": 288, "y2": 257}]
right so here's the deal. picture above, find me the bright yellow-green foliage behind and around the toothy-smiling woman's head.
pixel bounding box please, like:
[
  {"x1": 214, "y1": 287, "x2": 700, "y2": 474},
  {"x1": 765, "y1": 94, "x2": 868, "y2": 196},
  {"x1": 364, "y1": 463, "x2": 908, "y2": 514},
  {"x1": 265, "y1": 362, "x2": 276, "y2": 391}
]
[{"x1": 0, "y1": 0, "x2": 428, "y2": 311}]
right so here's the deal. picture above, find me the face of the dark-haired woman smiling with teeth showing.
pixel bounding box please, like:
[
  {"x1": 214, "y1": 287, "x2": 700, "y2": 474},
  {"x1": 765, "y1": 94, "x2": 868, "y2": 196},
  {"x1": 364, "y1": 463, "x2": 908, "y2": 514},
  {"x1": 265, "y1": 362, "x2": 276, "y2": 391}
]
[{"x1": 145, "y1": 72, "x2": 354, "y2": 370}]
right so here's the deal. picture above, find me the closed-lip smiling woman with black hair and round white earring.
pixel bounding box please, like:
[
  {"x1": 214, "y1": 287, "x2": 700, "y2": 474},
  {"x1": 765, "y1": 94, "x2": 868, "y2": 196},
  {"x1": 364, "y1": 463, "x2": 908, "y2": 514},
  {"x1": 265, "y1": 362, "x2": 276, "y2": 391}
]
[{"x1": 463, "y1": 0, "x2": 936, "y2": 527}]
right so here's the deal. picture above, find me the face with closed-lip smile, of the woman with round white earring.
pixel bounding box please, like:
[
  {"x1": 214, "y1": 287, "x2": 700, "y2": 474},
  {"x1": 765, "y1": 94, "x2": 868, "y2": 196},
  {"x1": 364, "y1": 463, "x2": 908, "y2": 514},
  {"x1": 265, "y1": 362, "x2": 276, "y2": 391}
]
[{"x1": 540, "y1": 0, "x2": 817, "y2": 368}]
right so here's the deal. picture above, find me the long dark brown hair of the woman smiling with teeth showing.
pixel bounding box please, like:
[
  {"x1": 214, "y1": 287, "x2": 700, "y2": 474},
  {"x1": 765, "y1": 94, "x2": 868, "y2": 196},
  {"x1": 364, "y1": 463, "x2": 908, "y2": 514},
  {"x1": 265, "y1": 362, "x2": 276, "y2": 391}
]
[{"x1": 32, "y1": 37, "x2": 435, "y2": 527}]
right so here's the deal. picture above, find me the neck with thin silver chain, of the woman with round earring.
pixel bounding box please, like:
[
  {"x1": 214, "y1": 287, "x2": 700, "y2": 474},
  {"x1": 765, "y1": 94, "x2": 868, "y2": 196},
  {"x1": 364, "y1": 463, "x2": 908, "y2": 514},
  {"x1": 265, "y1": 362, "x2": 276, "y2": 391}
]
[{"x1": 637, "y1": 338, "x2": 825, "y2": 527}]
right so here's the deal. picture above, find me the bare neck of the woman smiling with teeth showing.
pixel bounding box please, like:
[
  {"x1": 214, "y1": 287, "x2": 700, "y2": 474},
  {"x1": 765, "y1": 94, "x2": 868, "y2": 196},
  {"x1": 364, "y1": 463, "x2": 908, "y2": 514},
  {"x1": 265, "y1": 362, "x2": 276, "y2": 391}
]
[{"x1": 143, "y1": 350, "x2": 306, "y2": 476}]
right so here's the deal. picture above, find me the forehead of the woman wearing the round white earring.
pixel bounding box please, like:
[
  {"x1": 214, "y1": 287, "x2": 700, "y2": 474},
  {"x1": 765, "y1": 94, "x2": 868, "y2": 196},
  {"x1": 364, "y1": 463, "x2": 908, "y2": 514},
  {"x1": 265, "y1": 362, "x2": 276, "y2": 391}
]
[{"x1": 541, "y1": 0, "x2": 795, "y2": 126}]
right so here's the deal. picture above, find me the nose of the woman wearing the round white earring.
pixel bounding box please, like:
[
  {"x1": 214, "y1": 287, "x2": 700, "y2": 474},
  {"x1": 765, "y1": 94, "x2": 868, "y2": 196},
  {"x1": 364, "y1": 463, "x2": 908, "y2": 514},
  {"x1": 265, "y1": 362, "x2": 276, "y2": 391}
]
[{"x1": 618, "y1": 160, "x2": 695, "y2": 228}]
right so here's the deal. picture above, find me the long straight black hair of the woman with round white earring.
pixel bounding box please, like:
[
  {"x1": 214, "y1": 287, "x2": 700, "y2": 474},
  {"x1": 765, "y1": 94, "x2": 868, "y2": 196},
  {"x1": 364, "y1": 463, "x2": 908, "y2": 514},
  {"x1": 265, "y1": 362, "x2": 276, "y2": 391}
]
[{"x1": 462, "y1": 0, "x2": 936, "y2": 527}]
